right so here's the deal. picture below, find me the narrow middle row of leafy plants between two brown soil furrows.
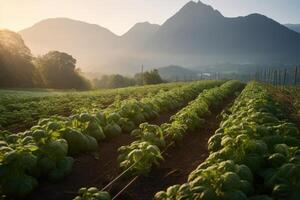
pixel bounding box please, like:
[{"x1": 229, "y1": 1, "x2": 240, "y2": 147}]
[{"x1": 75, "y1": 81, "x2": 244, "y2": 200}]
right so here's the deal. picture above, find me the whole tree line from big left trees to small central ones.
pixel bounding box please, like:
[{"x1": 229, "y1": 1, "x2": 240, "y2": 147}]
[{"x1": 0, "y1": 30, "x2": 163, "y2": 90}]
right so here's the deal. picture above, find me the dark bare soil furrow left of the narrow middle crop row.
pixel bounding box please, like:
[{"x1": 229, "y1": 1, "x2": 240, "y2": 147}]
[{"x1": 27, "y1": 111, "x2": 177, "y2": 200}]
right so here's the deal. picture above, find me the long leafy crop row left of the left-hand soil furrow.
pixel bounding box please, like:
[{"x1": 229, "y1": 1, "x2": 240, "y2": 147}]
[{"x1": 0, "y1": 81, "x2": 222, "y2": 198}]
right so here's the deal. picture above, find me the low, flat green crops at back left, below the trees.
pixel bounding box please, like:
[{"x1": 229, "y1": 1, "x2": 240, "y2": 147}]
[{"x1": 0, "y1": 83, "x2": 189, "y2": 130}]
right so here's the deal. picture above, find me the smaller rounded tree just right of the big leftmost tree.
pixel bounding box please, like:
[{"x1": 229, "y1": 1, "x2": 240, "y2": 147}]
[{"x1": 35, "y1": 51, "x2": 90, "y2": 89}]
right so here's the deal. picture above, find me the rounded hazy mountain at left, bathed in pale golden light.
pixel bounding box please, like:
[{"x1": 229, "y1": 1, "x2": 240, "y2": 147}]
[{"x1": 20, "y1": 18, "x2": 119, "y2": 72}]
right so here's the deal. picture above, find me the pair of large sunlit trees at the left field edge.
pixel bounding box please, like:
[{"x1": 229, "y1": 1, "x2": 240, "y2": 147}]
[{"x1": 0, "y1": 30, "x2": 91, "y2": 89}]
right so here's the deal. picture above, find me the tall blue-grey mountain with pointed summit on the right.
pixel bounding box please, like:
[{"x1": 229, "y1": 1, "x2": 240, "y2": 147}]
[{"x1": 149, "y1": 1, "x2": 300, "y2": 63}]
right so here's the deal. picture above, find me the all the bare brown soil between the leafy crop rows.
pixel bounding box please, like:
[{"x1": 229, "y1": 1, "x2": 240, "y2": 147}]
[{"x1": 27, "y1": 90, "x2": 240, "y2": 200}]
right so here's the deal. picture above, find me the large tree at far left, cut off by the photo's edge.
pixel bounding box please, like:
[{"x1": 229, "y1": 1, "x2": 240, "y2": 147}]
[{"x1": 0, "y1": 30, "x2": 41, "y2": 87}]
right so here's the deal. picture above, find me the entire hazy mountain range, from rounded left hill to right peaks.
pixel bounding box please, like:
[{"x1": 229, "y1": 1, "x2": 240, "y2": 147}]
[{"x1": 21, "y1": 1, "x2": 300, "y2": 74}]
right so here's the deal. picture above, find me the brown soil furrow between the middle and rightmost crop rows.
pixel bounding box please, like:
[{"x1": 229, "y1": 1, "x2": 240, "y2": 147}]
[{"x1": 110, "y1": 98, "x2": 238, "y2": 200}]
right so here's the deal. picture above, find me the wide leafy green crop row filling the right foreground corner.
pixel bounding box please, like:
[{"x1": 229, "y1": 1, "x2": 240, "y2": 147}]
[{"x1": 154, "y1": 82, "x2": 300, "y2": 200}]
